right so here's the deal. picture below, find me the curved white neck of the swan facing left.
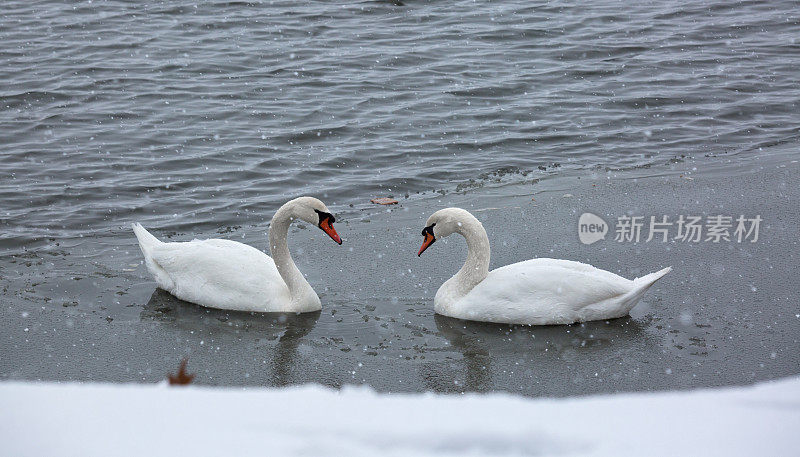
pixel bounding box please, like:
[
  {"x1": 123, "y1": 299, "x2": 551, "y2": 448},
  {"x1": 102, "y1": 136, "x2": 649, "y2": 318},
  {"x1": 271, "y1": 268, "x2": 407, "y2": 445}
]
[{"x1": 450, "y1": 214, "x2": 491, "y2": 296}]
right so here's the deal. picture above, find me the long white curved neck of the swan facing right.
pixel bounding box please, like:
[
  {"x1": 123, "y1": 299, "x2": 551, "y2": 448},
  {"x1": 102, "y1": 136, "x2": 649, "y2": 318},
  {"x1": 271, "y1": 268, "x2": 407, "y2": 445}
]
[{"x1": 269, "y1": 202, "x2": 316, "y2": 301}]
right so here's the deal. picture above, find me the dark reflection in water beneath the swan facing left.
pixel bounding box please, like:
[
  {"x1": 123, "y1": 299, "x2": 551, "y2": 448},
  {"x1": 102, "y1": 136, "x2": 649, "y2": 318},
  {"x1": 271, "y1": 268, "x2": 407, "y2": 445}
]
[{"x1": 422, "y1": 314, "x2": 647, "y2": 392}]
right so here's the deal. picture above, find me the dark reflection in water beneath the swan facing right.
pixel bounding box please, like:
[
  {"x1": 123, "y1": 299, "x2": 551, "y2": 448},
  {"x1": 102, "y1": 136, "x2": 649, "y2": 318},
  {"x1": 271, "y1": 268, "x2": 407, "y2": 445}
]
[{"x1": 140, "y1": 289, "x2": 321, "y2": 386}]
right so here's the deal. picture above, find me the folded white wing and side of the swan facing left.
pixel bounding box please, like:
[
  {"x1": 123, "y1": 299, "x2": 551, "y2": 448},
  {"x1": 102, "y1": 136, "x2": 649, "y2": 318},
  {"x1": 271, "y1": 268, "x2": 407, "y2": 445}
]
[{"x1": 453, "y1": 259, "x2": 633, "y2": 324}]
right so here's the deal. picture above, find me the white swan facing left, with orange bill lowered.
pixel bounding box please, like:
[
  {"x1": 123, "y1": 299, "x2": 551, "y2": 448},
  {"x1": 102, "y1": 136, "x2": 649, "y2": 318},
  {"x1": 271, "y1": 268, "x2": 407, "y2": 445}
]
[{"x1": 417, "y1": 208, "x2": 672, "y2": 325}]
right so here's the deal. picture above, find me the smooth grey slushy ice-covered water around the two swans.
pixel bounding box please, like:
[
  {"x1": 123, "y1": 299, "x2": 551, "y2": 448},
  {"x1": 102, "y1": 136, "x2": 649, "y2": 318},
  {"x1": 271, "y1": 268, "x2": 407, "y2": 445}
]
[{"x1": 0, "y1": 150, "x2": 800, "y2": 396}]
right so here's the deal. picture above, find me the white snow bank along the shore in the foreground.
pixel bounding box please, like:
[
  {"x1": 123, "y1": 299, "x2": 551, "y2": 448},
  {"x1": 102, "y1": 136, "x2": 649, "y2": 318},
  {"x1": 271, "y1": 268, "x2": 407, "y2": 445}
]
[{"x1": 0, "y1": 377, "x2": 800, "y2": 457}]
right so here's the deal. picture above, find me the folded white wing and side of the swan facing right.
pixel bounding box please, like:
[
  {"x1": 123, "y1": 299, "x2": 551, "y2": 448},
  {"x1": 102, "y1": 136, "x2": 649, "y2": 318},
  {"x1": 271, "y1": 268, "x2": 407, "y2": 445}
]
[{"x1": 152, "y1": 239, "x2": 290, "y2": 311}]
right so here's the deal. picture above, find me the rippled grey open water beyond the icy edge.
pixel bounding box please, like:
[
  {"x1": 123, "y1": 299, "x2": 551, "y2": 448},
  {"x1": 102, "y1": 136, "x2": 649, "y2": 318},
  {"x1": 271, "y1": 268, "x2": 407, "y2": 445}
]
[{"x1": 0, "y1": 0, "x2": 800, "y2": 252}]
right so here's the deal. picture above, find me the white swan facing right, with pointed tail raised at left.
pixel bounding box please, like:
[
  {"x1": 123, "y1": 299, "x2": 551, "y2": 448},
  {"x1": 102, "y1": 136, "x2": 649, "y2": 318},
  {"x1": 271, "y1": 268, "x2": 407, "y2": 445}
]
[{"x1": 133, "y1": 197, "x2": 342, "y2": 313}]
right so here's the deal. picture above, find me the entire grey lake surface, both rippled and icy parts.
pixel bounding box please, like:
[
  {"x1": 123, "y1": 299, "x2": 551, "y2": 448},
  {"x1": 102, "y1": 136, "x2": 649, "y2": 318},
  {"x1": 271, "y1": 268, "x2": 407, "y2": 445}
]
[{"x1": 0, "y1": 0, "x2": 800, "y2": 396}]
